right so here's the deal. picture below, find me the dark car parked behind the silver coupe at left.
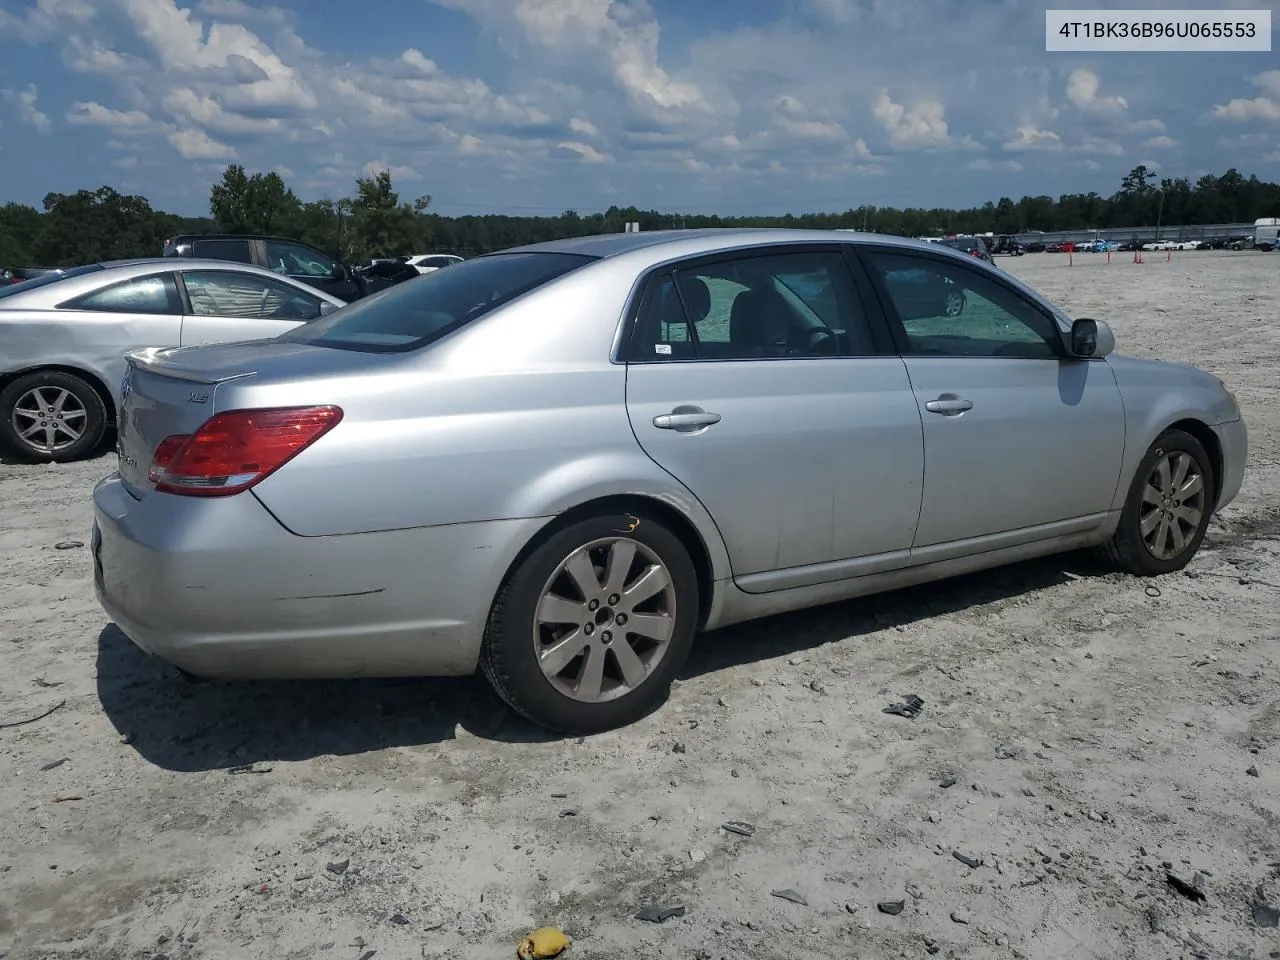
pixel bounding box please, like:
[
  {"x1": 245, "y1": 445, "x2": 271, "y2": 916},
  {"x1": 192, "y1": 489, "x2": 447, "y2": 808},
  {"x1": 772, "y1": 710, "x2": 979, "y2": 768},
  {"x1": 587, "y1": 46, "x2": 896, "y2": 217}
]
[{"x1": 164, "y1": 233, "x2": 419, "y2": 302}]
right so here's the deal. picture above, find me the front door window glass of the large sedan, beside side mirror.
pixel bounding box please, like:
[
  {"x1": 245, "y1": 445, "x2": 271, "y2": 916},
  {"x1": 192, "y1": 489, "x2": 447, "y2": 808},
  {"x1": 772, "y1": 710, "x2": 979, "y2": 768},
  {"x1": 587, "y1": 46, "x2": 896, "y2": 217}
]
[{"x1": 867, "y1": 253, "x2": 1062, "y2": 358}]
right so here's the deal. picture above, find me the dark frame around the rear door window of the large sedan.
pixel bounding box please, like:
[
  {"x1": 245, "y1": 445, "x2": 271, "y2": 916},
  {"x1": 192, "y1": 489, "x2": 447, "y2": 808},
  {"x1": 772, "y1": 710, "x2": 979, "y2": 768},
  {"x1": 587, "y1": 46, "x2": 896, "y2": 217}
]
[{"x1": 619, "y1": 241, "x2": 897, "y2": 366}]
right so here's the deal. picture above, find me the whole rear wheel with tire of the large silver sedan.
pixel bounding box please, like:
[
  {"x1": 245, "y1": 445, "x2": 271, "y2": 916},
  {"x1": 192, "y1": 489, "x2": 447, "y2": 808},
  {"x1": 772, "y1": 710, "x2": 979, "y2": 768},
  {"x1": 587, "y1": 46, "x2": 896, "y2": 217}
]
[{"x1": 480, "y1": 513, "x2": 699, "y2": 733}]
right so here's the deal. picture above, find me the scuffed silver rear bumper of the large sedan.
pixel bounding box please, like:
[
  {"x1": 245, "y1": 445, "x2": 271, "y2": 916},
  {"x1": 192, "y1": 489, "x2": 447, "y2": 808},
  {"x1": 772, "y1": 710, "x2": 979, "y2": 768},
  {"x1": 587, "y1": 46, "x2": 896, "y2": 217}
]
[{"x1": 92, "y1": 474, "x2": 545, "y2": 680}]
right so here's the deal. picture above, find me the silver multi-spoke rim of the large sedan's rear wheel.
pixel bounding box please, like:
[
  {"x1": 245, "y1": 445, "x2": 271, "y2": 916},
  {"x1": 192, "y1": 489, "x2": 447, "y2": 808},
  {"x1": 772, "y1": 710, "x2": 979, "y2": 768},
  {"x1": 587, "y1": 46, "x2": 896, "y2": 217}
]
[{"x1": 534, "y1": 536, "x2": 676, "y2": 703}]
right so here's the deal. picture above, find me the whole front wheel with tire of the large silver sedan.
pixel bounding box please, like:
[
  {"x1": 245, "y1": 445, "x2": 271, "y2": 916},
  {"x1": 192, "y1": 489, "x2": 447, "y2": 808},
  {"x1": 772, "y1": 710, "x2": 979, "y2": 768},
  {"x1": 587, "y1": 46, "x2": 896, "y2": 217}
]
[{"x1": 1103, "y1": 430, "x2": 1217, "y2": 576}]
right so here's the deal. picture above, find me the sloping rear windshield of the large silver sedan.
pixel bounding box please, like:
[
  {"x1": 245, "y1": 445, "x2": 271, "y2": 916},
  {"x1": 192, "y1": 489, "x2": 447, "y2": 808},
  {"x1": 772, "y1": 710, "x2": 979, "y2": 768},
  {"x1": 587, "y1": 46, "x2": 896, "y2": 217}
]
[{"x1": 276, "y1": 253, "x2": 595, "y2": 353}]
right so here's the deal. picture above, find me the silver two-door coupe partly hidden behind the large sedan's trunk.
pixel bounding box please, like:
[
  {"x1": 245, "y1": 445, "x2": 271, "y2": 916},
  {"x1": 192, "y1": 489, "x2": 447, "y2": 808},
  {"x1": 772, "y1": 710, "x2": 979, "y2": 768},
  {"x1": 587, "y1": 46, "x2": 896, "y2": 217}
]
[{"x1": 0, "y1": 257, "x2": 343, "y2": 462}]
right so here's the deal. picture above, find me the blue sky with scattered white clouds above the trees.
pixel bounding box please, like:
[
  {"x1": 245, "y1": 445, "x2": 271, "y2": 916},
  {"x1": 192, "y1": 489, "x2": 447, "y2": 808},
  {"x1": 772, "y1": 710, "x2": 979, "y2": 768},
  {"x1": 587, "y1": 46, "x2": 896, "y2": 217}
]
[{"x1": 0, "y1": 0, "x2": 1280, "y2": 214}]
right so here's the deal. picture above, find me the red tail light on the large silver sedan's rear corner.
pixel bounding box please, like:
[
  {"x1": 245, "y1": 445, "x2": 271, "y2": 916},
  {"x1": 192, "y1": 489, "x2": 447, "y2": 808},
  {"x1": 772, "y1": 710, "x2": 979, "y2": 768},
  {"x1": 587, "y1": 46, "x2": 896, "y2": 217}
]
[{"x1": 147, "y1": 407, "x2": 342, "y2": 497}]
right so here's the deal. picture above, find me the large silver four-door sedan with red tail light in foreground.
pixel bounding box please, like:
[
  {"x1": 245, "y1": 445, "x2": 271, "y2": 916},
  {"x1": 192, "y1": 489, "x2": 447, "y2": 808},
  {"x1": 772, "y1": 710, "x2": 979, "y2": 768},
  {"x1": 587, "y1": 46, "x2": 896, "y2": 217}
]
[{"x1": 92, "y1": 230, "x2": 1247, "y2": 731}]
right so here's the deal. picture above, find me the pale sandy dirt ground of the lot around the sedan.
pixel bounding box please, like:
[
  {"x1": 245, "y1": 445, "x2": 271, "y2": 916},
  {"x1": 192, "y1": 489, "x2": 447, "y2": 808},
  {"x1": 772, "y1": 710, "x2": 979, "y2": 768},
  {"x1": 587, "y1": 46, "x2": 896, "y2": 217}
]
[{"x1": 0, "y1": 252, "x2": 1280, "y2": 960}]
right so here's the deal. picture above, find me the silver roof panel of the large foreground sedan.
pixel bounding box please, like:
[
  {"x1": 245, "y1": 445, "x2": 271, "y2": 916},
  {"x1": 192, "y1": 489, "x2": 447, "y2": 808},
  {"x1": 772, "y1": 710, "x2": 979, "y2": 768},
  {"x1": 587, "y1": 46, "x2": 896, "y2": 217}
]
[{"x1": 502, "y1": 227, "x2": 962, "y2": 262}]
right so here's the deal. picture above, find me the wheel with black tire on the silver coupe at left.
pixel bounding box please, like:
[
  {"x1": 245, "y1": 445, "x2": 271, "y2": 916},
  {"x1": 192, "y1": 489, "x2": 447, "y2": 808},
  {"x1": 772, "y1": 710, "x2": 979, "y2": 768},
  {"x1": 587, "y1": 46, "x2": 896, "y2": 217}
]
[{"x1": 0, "y1": 370, "x2": 106, "y2": 463}]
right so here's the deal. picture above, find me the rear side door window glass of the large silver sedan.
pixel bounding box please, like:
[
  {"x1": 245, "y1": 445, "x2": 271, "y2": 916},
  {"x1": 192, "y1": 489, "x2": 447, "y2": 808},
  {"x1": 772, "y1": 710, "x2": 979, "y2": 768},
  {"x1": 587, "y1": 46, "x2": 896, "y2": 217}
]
[{"x1": 632, "y1": 252, "x2": 876, "y2": 361}]
